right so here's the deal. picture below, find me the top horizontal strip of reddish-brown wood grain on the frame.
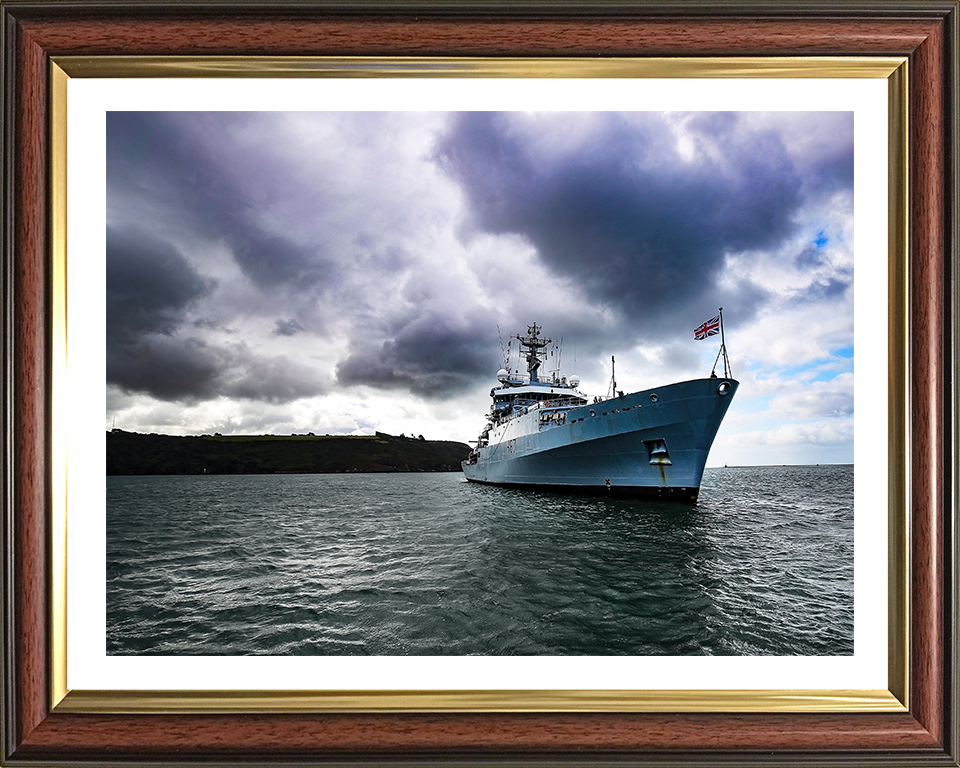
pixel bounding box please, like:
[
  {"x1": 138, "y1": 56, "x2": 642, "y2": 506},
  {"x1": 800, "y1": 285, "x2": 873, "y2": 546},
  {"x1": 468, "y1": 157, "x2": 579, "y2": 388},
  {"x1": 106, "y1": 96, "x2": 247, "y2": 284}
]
[{"x1": 15, "y1": 18, "x2": 936, "y2": 56}]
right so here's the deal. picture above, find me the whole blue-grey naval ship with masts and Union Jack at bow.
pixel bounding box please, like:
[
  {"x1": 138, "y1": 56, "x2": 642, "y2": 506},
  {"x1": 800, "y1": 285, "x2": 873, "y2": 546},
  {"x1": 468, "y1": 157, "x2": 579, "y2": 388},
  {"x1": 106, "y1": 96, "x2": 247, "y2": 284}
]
[{"x1": 462, "y1": 316, "x2": 740, "y2": 502}]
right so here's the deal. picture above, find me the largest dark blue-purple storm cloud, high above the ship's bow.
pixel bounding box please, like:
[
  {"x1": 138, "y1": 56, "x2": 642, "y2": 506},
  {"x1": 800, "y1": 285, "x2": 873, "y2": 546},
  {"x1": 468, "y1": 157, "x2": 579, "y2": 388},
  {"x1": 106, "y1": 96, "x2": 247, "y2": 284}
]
[{"x1": 437, "y1": 112, "x2": 845, "y2": 327}]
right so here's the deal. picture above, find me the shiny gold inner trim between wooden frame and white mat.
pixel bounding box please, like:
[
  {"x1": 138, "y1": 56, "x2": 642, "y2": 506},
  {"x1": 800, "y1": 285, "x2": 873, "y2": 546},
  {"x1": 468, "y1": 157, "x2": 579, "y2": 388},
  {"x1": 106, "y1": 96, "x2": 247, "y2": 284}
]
[{"x1": 49, "y1": 56, "x2": 910, "y2": 714}]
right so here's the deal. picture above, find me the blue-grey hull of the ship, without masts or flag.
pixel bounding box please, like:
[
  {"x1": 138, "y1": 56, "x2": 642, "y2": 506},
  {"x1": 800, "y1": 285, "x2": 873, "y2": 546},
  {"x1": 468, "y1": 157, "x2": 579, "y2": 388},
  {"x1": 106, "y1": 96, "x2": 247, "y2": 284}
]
[{"x1": 463, "y1": 378, "x2": 739, "y2": 501}]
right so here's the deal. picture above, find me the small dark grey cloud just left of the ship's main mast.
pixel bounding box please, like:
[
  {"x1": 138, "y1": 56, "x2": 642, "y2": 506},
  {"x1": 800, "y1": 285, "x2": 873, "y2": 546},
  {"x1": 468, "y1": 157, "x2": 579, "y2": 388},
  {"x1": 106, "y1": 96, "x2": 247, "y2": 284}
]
[{"x1": 337, "y1": 311, "x2": 499, "y2": 396}]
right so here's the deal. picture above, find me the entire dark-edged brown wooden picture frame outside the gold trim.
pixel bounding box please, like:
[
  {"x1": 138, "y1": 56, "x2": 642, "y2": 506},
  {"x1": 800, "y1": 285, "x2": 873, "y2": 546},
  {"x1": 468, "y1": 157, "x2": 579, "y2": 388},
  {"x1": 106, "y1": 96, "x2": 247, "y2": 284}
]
[{"x1": 0, "y1": 0, "x2": 960, "y2": 766}]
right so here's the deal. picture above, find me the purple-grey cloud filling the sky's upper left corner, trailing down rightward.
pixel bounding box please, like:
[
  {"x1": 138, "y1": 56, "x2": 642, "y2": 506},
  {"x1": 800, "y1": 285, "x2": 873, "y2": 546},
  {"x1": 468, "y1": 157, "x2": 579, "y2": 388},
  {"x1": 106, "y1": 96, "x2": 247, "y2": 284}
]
[{"x1": 107, "y1": 112, "x2": 336, "y2": 286}]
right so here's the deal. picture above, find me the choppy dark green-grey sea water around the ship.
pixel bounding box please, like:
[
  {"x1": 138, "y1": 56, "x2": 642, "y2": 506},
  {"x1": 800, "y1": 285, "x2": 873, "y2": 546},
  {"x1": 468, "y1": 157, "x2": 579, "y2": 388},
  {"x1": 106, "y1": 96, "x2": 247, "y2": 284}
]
[{"x1": 106, "y1": 465, "x2": 853, "y2": 655}]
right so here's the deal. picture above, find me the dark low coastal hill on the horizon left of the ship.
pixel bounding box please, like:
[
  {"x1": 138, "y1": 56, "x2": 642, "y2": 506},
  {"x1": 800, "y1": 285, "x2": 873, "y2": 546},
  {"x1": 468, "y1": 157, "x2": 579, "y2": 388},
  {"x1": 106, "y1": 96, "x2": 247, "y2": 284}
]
[{"x1": 107, "y1": 429, "x2": 470, "y2": 475}]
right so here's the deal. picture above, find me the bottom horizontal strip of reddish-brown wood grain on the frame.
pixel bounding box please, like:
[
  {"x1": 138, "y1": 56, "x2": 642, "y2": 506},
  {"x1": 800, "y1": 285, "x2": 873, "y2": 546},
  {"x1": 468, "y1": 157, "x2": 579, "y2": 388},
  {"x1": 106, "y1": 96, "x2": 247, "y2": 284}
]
[{"x1": 13, "y1": 714, "x2": 937, "y2": 756}]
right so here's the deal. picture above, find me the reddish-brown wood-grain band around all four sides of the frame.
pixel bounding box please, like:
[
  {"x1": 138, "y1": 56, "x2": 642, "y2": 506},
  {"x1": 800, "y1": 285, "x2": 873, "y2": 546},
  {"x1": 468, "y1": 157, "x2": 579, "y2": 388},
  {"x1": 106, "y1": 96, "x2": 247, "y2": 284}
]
[{"x1": 1, "y1": 6, "x2": 956, "y2": 765}]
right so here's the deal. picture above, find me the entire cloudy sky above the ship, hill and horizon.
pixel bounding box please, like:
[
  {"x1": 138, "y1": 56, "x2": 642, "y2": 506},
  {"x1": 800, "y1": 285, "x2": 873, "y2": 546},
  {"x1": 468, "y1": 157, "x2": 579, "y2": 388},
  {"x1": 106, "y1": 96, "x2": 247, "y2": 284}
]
[{"x1": 106, "y1": 112, "x2": 853, "y2": 465}]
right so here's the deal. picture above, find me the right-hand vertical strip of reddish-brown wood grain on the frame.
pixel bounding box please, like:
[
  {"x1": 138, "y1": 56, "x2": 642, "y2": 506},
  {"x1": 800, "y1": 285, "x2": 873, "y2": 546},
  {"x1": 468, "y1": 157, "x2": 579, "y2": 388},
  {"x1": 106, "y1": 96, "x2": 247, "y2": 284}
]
[{"x1": 910, "y1": 12, "x2": 949, "y2": 741}]
